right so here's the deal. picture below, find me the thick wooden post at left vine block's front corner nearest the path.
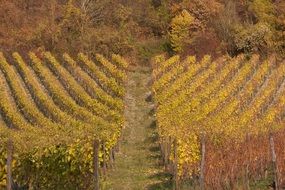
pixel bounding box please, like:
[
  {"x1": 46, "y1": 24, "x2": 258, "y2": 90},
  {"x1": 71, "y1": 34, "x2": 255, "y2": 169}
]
[{"x1": 93, "y1": 140, "x2": 100, "y2": 190}]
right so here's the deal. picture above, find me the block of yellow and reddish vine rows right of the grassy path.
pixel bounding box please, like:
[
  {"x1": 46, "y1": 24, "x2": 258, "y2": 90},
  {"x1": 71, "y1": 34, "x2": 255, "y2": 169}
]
[{"x1": 152, "y1": 55, "x2": 285, "y2": 189}]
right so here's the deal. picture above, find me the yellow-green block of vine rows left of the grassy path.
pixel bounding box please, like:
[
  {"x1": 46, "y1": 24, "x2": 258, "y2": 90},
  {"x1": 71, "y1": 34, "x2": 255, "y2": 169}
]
[{"x1": 0, "y1": 52, "x2": 128, "y2": 189}]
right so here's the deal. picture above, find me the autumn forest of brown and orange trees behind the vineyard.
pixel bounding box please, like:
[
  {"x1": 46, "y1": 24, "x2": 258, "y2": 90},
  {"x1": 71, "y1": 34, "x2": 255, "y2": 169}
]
[{"x1": 0, "y1": 0, "x2": 285, "y2": 60}]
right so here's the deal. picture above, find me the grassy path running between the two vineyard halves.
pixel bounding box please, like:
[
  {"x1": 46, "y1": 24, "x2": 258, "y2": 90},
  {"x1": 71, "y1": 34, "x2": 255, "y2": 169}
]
[{"x1": 103, "y1": 67, "x2": 169, "y2": 190}]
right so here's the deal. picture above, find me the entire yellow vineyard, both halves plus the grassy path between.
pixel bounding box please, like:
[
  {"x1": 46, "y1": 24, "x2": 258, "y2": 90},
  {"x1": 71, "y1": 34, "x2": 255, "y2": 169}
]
[{"x1": 0, "y1": 52, "x2": 285, "y2": 190}]
